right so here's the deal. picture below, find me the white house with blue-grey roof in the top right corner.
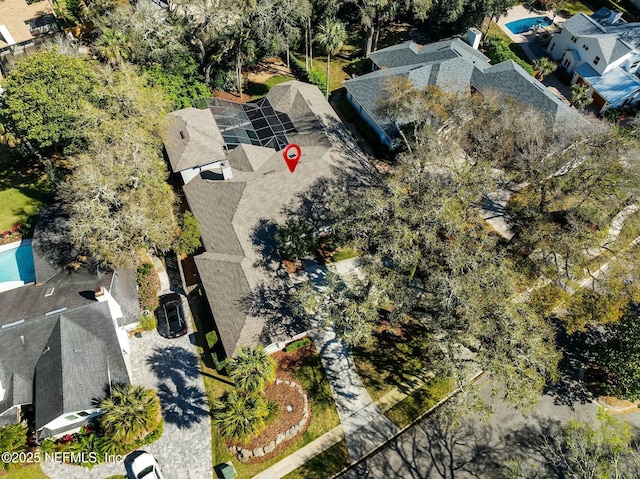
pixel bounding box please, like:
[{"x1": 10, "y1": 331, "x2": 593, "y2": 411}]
[{"x1": 547, "y1": 8, "x2": 640, "y2": 112}]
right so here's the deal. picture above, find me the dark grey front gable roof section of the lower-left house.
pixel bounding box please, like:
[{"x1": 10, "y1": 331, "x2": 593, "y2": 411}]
[{"x1": 35, "y1": 302, "x2": 129, "y2": 429}]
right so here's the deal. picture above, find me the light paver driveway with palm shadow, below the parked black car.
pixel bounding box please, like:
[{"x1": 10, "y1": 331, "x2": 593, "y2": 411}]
[{"x1": 42, "y1": 316, "x2": 213, "y2": 479}]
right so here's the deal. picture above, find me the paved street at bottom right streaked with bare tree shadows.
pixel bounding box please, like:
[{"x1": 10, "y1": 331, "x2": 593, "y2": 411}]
[{"x1": 340, "y1": 380, "x2": 640, "y2": 479}]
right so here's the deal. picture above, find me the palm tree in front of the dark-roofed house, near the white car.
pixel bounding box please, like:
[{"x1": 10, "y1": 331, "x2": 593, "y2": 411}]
[{"x1": 99, "y1": 384, "x2": 162, "y2": 446}]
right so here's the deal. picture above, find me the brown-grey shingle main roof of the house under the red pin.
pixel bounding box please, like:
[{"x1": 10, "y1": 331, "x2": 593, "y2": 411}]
[{"x1": 172, "y1": 81, "x2": 366, "y2": 355}]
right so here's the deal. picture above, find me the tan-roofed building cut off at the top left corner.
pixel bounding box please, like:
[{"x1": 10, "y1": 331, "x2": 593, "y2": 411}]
[{"x1": 0, "y1": 0, "x2": 60, "y2": 76}]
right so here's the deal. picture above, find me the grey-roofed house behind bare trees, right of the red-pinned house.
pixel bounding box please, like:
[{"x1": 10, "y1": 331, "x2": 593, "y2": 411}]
[{"x1": 344, "y1": 37, "x2": 577, "y2": 147}]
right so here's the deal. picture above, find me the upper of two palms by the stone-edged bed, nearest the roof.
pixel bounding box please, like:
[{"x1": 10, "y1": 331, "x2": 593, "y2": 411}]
[{"x1": 229, "y1": 346, "x2": 276, "y2": 392}]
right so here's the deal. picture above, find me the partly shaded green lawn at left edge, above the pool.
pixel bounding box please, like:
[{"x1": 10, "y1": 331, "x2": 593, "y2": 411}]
[{"x1": 0, "y1": 145, "x2": 52, "y2": 230}]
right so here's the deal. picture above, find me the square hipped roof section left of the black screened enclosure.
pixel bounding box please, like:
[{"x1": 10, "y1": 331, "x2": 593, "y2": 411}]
[{"x1": 162, "y1": 108, "x2": 225, "y2": 172}]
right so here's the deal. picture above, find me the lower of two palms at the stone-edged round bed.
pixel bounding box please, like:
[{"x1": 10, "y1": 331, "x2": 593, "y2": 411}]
[{"x1": 211, "y1": 389, "x2": 269, "y2": 444}]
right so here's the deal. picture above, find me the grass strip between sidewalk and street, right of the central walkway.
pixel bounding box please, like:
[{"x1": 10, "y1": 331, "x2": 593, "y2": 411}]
[{"x1": 385, "y1": 378, "x2": 455, "y2": 428}]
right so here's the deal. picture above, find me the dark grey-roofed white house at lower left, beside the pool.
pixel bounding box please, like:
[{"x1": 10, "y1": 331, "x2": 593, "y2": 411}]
[{"x1": 0, "y1": 207, "x2": 140, "y2": 440}]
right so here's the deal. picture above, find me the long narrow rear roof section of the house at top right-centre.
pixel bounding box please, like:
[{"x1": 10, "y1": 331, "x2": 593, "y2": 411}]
[{"x1": 369, "y1": 37, "x2": 489, "y2": 68}]
